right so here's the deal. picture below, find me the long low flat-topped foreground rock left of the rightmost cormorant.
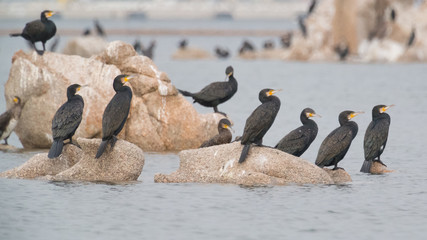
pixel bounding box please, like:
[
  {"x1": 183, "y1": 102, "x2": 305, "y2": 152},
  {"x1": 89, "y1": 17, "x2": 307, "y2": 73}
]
[{"x1": 154, "y1": 142, "x2": 351, "y2": 185}]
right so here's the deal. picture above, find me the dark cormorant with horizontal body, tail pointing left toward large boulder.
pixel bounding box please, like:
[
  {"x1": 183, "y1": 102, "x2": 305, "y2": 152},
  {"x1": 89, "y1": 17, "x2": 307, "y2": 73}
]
[{"x1": 178, "y1": 66, "x2": 237, "y2": 116}]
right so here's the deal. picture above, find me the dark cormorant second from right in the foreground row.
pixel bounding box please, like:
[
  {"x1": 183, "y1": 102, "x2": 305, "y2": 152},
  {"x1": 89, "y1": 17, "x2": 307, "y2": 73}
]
[{"x1": 316, "y1": 111, "x2": 363, "y2": 170}]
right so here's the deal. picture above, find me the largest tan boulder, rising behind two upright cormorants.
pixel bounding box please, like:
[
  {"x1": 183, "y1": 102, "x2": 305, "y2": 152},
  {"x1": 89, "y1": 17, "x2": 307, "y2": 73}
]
[{"x1": 5, "y1": 41, "x2": 222, "y2": 151}]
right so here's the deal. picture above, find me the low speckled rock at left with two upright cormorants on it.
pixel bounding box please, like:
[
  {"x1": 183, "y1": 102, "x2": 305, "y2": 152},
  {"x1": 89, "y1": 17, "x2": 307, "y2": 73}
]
[{"x1": 0, "y1": 138, "x2": 144, "y2": 182}]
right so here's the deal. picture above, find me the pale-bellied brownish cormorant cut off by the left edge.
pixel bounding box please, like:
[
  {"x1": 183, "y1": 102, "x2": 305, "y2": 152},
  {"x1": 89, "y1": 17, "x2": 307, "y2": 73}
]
[{"x1": 0, "y1": 97, "x2": 22, "y2": 145}]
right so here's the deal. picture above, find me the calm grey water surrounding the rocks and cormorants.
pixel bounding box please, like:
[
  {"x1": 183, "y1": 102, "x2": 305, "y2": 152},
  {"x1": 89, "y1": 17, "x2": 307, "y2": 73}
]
[{"x1": 0, "y1": 18, "x2": 427, "y2": 240}]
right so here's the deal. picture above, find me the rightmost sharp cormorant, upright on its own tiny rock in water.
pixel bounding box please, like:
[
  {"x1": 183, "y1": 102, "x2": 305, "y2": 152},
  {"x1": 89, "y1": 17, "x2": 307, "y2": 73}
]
[{"x1": 360, "y1": 105, "x2": 394, "y2": 173}]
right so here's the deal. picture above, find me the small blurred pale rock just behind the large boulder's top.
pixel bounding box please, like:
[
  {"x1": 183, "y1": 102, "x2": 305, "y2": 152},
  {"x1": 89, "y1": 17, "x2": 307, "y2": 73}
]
[{"x1": 62, "y1": 36, "x2": 108, "y2": 58}]
